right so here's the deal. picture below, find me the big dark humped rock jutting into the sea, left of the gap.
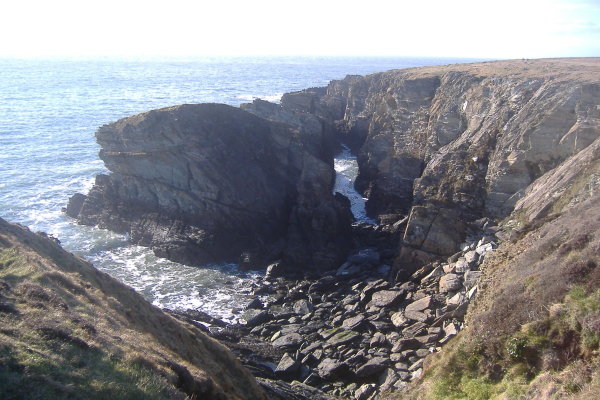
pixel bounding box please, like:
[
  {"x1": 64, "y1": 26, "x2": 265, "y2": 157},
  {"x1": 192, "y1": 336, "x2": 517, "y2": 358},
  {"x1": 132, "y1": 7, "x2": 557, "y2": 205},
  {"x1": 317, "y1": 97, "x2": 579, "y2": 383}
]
[{"x1": 66, "y1": 104, "x2": 352, "y2": 271}]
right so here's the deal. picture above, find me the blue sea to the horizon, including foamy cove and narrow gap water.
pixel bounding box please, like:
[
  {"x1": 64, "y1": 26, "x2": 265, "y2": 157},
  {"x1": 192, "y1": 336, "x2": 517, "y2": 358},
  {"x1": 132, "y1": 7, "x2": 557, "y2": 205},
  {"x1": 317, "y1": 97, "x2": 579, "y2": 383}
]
[{"x1": 0, "y1": 57, "x2": 480, "y2": 322}]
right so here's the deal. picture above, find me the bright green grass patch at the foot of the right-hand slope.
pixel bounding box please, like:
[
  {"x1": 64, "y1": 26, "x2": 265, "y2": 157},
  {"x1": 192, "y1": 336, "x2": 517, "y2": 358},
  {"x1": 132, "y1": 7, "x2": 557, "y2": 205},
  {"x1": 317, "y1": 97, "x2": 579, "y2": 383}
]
[{"x1": 426, "y1": 286, "x2": 600, "y2": 400}]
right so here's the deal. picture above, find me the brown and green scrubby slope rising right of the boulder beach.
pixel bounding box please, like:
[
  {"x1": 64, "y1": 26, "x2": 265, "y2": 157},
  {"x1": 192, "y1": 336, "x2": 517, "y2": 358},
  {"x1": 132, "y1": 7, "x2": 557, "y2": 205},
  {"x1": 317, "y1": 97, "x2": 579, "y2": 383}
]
[{"x1": 395, "y1": 168, "x2": 600, "y2": 399}]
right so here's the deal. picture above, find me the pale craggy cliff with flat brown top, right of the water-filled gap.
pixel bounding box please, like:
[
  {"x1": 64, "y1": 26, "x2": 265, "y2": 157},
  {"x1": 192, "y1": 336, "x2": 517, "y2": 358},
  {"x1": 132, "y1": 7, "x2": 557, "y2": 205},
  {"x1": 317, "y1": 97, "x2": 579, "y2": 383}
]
[{"x1": 282, "y1": 59, "x2": 600, "y2": 274}]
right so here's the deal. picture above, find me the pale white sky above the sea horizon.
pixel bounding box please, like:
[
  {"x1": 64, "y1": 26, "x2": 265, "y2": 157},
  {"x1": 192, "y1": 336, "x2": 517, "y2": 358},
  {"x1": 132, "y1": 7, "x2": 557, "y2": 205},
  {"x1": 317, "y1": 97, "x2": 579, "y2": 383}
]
[{"x1": 0, "y1": 0, "x2": 600, "y2": 58}]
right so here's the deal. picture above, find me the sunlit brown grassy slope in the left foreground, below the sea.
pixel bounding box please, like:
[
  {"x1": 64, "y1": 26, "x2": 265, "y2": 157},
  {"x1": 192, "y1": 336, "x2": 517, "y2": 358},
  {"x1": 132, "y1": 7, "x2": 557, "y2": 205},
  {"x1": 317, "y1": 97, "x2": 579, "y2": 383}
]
[{"x1": 0, "y1": 219, "x2": 264, "y2": 399}]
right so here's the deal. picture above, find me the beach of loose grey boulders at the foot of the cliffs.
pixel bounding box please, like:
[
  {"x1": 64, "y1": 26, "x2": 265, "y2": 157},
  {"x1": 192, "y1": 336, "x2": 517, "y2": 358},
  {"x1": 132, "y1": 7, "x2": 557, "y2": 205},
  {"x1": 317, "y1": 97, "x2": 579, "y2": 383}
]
[{"x1": 170, "y1": 219, "x2": 501, "y2": 400}]
